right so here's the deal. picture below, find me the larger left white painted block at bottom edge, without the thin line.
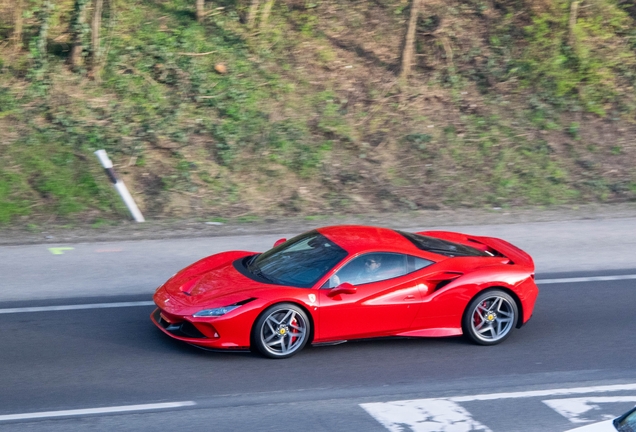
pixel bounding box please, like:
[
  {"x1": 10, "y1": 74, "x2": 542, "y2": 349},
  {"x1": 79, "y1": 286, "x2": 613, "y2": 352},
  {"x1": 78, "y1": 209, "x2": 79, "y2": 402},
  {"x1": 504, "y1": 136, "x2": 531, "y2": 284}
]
[{"x1": 360, "y1": 399, "x2": 492, "y2": 432}]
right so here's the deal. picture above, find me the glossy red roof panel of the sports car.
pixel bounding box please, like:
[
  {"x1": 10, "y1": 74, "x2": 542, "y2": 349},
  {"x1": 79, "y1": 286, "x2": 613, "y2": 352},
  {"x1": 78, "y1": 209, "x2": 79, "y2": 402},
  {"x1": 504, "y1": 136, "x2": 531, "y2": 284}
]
[{"x1": 317, "y1": 225, "x2": 428, "y2": 256}]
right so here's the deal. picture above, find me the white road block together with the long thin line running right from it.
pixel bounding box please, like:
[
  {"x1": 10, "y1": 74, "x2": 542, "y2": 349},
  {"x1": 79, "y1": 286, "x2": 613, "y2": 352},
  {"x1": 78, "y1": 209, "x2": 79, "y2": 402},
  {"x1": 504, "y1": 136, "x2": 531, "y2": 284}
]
[{"x1": 360, "y1": 383, "x2": 636, "y2": 432}]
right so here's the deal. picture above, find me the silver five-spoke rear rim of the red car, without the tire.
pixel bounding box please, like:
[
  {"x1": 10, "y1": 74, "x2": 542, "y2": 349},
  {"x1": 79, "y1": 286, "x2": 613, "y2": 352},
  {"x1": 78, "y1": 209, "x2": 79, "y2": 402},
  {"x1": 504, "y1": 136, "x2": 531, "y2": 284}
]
[{"x1": 470, "y1": 293, "x2": 516, "y2": 343}]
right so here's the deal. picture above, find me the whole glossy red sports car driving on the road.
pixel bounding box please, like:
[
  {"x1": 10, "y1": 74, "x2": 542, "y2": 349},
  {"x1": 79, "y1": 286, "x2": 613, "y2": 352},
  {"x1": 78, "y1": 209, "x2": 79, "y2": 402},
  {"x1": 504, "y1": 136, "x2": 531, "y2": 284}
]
[{"x1": 151, "y1": 226, "x2": 538, "y2": 358}]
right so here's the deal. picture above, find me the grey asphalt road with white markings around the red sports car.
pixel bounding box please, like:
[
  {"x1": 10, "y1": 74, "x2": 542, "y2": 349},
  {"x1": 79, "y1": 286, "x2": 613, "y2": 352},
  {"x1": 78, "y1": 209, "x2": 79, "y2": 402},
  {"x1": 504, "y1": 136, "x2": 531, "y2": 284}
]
[{"x1": 0, "y1": 221, "x2": 636, "y2": 432}]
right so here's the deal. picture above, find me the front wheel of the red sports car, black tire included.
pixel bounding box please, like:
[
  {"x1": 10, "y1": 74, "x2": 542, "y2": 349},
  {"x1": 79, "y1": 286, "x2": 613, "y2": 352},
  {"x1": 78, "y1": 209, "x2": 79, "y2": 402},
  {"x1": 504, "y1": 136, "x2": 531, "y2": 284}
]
[{"x1": 252, "y1": 303, "x2": 311, "y2": 359}]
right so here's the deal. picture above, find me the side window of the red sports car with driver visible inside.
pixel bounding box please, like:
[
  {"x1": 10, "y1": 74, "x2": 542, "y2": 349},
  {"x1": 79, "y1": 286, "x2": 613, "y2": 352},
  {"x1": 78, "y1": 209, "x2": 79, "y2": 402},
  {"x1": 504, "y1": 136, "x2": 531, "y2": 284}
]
[{"x1": 323, "y1": 252, "x2": 432, "y2": 288}]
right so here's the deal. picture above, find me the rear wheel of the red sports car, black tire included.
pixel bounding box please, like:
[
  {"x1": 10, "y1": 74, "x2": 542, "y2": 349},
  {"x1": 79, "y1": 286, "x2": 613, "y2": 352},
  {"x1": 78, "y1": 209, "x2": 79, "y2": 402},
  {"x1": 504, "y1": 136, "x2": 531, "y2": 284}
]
[{"x1": 462, "y1": 289, "x2": 519, "y2": 345}]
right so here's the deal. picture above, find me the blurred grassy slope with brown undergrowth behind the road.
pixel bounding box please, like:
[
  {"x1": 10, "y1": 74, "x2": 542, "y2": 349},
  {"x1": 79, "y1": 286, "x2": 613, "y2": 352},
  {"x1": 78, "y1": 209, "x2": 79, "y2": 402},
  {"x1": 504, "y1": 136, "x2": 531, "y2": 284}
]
[{"x1": 0, "y1": 0, "x2": 636, "y2": 223}]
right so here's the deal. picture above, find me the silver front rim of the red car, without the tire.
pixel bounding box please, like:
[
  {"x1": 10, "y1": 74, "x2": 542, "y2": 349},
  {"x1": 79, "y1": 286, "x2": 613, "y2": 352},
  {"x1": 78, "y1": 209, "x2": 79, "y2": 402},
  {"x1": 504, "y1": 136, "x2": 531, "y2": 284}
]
[{"x1": 260, "y1": 308, "x2": 308, "y2": 357}]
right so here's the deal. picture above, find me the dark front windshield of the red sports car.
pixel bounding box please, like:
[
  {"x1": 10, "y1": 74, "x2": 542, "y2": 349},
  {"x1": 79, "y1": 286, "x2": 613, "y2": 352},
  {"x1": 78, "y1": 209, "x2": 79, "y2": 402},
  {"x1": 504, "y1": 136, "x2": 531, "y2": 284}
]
[{"x1": 247, "y1": 231, "x2": 347, "y2": 288}]
